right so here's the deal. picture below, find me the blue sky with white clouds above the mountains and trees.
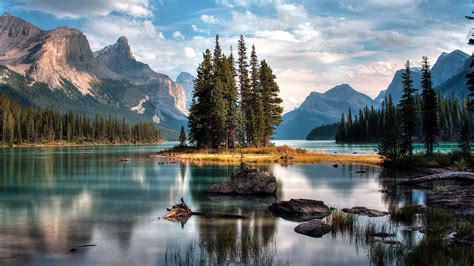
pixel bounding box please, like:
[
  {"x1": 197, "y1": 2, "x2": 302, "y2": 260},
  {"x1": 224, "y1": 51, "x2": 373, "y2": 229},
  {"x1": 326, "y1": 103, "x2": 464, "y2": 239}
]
[{"x1": 0, "y1": 0, "x2": 474, "y2": 111}]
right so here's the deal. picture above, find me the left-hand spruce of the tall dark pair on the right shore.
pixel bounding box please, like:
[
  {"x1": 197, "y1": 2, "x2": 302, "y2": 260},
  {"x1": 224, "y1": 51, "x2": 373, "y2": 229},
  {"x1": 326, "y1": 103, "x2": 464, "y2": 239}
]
[{"x1": 399, "y1": 61, "x2": 416, "y2": 157}]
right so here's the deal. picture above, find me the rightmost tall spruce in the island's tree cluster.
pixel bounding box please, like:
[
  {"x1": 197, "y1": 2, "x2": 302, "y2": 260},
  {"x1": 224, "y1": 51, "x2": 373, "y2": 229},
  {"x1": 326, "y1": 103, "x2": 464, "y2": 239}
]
[{"x1": 260, "y1": 60, "x2": 283, "y2": 145}]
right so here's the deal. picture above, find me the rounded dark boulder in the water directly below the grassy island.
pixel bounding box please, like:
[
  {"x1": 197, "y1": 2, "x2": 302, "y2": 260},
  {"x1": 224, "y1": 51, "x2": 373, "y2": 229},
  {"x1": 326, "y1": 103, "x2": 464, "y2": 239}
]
[{"x1": 208, "y1": 169, "x2": 277, "y2": 195}]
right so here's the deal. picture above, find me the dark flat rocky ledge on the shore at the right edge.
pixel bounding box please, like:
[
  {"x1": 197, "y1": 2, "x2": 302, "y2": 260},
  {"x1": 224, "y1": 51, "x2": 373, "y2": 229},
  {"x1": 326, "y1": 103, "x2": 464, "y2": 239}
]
[{"x1": 426, "y1": 185, "x2": 474, "y2": 216}]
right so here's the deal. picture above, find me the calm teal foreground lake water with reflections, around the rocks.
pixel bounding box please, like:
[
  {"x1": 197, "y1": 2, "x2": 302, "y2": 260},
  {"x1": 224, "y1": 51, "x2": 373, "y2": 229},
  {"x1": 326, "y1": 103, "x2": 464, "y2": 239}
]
[{"x1": 0, "y1": 144, "x2": 425, "y2": 265}]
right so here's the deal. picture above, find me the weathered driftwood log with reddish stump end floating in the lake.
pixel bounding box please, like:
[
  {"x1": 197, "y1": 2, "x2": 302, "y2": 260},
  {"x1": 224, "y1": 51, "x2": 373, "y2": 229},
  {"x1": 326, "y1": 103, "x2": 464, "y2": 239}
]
[{"x1": 163, "y1": 198, "x2": 247, "y2": 221}]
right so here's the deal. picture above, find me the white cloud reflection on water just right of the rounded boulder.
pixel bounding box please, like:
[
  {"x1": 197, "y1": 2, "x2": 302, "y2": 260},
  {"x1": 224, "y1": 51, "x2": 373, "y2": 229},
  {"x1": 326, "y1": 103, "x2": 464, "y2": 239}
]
[{"x1": 273, "y1": 164, "x2": 387, "y2": 210}]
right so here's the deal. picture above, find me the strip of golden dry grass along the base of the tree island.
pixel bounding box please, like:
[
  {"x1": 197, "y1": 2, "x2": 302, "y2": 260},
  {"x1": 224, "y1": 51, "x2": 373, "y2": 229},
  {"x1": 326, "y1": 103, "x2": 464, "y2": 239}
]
[{"x1": 156, "y1": 145, "x2": 381, "y2": 165}]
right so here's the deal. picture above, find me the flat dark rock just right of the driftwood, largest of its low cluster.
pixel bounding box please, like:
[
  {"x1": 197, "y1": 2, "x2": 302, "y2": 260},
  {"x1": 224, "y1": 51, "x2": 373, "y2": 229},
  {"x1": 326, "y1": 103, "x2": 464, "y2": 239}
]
[{"x1": 268, "y1": 199, "x2": 331, "y2": 222}]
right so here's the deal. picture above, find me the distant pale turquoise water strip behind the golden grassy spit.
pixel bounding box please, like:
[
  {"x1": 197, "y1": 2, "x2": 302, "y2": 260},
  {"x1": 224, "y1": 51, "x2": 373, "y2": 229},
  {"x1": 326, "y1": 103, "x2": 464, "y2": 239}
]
[{"x1": 273, "y1": 140, "x2": 458, "y2": 154}]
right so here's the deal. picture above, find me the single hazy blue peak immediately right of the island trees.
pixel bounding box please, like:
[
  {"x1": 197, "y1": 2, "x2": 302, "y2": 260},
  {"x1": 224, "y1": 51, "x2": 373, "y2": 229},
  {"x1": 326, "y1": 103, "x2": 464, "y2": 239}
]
[{"x1": 274, "y1": 84, "x2": 378, "y2": 139}]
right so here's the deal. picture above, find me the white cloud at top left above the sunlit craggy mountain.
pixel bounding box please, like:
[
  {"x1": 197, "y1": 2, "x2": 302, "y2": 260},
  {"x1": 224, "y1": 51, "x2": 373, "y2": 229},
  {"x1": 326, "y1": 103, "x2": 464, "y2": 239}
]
[{"x1": 17, "y1": 0, "x2": 153, "y2": 19}]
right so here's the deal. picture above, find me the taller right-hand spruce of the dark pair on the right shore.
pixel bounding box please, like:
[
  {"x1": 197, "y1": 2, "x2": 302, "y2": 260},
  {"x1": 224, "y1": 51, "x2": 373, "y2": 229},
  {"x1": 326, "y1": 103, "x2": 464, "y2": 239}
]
[{"x1": 421, "y1": 56, "x2": 439, "y2": 156}]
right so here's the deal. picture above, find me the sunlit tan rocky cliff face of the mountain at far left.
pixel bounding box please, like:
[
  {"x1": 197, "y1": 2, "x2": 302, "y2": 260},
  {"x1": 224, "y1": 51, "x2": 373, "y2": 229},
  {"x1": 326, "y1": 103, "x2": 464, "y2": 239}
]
[{"x1": 0, "y1": 15, "x2": 118, "y2": 95}]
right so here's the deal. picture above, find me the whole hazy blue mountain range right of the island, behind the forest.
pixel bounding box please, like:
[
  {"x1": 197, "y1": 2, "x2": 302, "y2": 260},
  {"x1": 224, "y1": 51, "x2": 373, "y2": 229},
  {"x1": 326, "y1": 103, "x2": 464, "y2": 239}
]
[{"x1": 274, "y1": 50, "x2": 470, "y2": 139}]
